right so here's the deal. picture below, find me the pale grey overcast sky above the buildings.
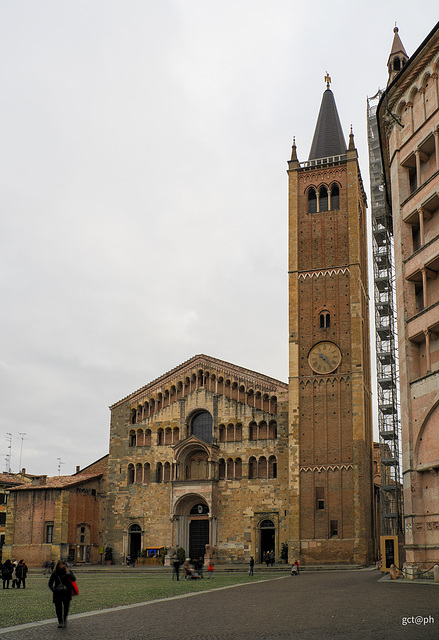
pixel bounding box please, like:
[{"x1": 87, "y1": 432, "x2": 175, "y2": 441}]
[{"x1": 0, "y1": 0, "x2": 435, "y2": 475}]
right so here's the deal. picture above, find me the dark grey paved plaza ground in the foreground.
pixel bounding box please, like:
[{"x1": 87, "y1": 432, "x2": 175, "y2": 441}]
[{"x1": 0, "y1": 570, "x2": 439, "y2": 640}]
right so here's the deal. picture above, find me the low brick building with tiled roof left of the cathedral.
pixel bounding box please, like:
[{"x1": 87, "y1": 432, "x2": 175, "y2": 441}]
[{"x1": 3, "y1": 456, "x2": 108, "y2": 567}]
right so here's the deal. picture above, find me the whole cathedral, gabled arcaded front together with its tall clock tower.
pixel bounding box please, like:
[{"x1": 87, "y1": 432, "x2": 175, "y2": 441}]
[{"x1": 106, "y1": 78, "x2": 374, "y2": 564}]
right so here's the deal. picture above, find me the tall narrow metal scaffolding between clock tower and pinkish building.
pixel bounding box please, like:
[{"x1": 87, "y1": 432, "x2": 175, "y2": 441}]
[{"x1": 367, "y1": 91, "x2": 402, "y2": 536}]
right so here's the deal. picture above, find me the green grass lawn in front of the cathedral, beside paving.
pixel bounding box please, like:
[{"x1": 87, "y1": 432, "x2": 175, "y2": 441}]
[{"x1": 0, "y1": 569, "x2": 279, "y2": 628}]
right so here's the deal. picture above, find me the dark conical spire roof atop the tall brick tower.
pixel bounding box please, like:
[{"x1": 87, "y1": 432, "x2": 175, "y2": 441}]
[{"x1": 308, "y1": 89, "x2": 347, "y2": 160}]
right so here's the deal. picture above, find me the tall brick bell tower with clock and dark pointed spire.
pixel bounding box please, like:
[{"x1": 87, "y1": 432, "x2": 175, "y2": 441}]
[{"x1": 288, "y1": 75, "x2": 373, "y2": 564}]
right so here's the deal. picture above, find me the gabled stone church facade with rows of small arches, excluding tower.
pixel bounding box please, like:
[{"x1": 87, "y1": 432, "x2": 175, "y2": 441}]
[{"x1": 106, "y1": 355, "x2": 290, "y2": 563}]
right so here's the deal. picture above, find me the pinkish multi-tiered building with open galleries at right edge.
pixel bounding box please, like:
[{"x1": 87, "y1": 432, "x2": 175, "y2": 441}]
[{"x1": 377, "y1": 23, "x2": 439, "y2": 570}]
